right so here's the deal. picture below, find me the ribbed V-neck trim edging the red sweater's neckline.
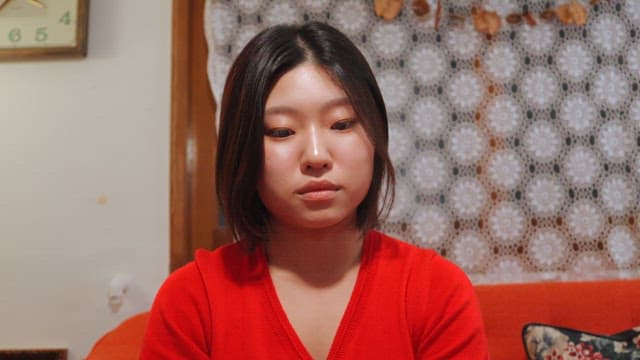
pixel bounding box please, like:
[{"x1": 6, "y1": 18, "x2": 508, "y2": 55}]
[{"x1": 260, "y1": 231, "x2": 377, "y2": 360}]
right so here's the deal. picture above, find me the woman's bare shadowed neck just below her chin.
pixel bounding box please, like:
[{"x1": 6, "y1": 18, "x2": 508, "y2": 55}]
[{"x1": 265, "y1": 224, "x2": 363, "y2": 288}]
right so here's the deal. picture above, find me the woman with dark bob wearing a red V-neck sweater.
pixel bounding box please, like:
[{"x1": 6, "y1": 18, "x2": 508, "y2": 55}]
[{"x1": 141, "y1": 22, "x2": 488, "y2": 359}]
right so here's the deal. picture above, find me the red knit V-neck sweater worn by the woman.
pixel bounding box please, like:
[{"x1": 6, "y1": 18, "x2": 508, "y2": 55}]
[{"x1": 141, "y1": 231, "x2": 488, "y2": 360}]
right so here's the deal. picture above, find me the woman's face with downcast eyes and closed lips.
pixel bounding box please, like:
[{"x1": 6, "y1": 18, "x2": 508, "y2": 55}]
[{"x1": 258, "y1": 63, "x2": 374, "y2": 229}]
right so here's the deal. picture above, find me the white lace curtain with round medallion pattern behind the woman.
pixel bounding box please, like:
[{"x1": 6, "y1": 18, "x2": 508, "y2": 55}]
[{"x1": 205, "y1": 0, "x2": 640, "y2": 283}]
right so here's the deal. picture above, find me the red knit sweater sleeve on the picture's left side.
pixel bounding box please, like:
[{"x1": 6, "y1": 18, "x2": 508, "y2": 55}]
[{"x1": 140, "y1": 262, "x2": 212, "y2": 360}]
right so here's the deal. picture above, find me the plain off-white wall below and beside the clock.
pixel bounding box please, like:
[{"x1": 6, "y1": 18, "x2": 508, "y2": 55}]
[{"x1": 0, "y1": 0, "x2": 171, "y2": 360}]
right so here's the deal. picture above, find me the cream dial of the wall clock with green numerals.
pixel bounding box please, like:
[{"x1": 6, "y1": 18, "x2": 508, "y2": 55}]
[{"x1": 0, "y1": 0, "x2": 86, "y2": 56}]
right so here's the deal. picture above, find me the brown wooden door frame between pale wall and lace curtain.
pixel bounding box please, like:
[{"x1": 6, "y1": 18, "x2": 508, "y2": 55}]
[{"x1": 169, "y1": 0, "x2": 228, "y2": 271}]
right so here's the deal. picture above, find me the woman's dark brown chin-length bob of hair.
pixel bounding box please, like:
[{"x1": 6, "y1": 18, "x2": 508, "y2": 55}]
[{"x1": 216, "y1": 22, "x2": 395, "y2": 248}]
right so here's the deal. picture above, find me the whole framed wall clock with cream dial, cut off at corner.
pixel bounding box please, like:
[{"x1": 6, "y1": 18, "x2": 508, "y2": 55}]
[{"x1": 0, "y1": 0, "x2": 89, "y2": 60}]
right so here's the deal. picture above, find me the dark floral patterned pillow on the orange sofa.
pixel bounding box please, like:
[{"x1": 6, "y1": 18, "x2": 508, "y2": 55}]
[{"x1": 522, "y1": 323, "x2": 640, "y2": 360}]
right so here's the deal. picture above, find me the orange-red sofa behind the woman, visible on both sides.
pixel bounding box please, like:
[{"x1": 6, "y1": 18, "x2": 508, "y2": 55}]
[{"x1": 87, "y1": 279, "x2": 640, "y2": 360}]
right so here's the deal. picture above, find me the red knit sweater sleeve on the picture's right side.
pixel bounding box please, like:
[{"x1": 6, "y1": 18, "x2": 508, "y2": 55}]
[{"x1": 407, "y1": 251, "x2": 489, "y2": 360}]
